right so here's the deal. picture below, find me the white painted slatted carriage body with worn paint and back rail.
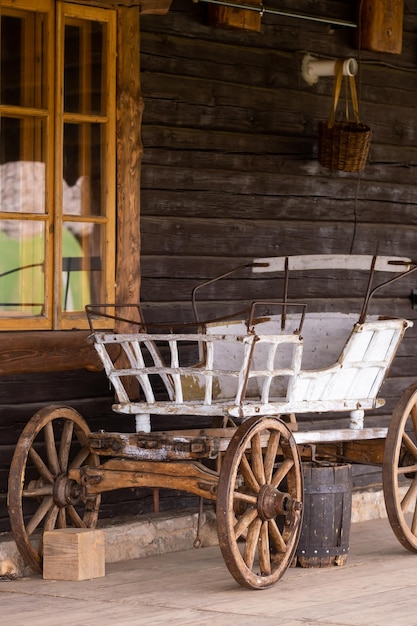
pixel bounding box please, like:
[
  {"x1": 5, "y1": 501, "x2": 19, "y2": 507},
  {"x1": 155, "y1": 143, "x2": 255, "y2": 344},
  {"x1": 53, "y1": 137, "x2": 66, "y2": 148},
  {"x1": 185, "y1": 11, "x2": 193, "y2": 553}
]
[{"x1": 88, "y1": 255, "x2": 412, "y2": 434}]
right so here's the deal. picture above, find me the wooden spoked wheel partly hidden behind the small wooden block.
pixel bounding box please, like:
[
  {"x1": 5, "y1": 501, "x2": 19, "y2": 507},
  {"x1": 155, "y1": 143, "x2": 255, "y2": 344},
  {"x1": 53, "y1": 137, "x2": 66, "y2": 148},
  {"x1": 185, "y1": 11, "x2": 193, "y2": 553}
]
[{"x1": 8, "y1": 406, "x2": 100, "y2": 572}]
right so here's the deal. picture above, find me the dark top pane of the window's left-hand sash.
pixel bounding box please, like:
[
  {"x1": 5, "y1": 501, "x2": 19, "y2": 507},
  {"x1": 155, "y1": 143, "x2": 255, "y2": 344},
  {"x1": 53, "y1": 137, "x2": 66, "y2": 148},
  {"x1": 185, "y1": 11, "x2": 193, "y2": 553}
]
[{"x1": 0, "y1": 8, "x2": 47, "y2": 108}]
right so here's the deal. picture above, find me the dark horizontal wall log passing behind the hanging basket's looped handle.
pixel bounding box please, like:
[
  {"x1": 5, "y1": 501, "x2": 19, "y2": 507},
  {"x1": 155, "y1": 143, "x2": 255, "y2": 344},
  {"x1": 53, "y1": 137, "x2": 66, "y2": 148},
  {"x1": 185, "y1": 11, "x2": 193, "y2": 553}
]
[{"x1": 142, "y1": 66, "x2": 415, "y2": 145}]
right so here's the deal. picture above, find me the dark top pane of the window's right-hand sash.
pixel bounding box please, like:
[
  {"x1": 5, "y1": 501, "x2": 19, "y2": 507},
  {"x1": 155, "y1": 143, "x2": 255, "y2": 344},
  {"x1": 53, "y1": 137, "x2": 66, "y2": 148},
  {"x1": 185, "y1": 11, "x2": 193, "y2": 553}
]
[{"x1": 64, "y1": 19, "x2": 107, "y2": 115}]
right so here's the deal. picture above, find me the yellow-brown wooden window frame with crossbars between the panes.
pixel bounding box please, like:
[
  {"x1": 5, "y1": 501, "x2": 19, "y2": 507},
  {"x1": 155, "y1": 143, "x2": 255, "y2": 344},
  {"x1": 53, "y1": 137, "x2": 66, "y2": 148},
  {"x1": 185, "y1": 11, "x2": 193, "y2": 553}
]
[{"x1": 0, "y1": 0, "x2": 117, "y2": 331}]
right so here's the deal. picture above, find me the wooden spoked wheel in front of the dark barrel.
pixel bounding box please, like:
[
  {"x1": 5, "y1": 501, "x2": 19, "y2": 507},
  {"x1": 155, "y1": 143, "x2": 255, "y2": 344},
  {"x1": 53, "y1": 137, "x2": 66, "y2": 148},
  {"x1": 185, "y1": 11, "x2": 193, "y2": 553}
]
[{"x1": 216, "y1": 416, "x2": 303, "y2": 589}]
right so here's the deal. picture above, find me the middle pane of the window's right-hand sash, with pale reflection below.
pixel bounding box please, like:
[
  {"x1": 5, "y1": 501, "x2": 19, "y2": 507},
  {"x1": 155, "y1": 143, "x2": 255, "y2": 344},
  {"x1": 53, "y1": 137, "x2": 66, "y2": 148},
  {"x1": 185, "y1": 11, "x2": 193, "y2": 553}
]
[{"x1": 63, "y1": 123, "x2": 105, "y2": 216}]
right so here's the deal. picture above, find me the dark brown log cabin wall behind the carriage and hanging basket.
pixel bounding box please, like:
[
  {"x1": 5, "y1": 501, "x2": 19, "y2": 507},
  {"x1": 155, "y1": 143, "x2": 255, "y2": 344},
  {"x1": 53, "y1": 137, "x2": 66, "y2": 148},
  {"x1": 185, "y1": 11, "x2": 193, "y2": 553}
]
[{"x1": 0, "y1": 0, "x2": 417, "y2": 531}]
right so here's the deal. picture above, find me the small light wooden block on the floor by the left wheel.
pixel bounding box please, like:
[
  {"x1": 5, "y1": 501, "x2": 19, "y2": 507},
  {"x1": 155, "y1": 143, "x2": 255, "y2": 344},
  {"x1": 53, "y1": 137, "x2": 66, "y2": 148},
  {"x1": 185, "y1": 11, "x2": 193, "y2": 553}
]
[{"x1": 43, "y1": 528, "x2": 105, "y2": 580}]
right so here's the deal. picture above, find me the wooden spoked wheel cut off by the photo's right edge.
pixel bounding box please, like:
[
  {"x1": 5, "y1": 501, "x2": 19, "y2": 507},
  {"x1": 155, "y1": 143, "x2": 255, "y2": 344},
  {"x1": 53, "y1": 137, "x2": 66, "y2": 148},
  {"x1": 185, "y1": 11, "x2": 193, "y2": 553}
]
[{"x1": 382, "y1": 383, "x2": 417, "y2": 552}]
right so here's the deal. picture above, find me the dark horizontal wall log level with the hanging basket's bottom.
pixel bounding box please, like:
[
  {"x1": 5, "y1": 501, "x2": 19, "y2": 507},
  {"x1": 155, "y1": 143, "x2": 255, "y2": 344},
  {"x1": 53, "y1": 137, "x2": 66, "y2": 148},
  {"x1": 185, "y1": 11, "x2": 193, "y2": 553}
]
[{"x1": 142, "y1": 158, "x2": 417, "y2": 205}]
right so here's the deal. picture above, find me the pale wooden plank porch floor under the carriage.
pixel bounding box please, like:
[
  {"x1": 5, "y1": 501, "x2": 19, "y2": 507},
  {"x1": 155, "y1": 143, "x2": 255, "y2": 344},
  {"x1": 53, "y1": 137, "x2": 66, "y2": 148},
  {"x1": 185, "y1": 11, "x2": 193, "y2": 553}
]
[{"x1": 0, "y1": 519, "x2": 417, "y2": 626}]
